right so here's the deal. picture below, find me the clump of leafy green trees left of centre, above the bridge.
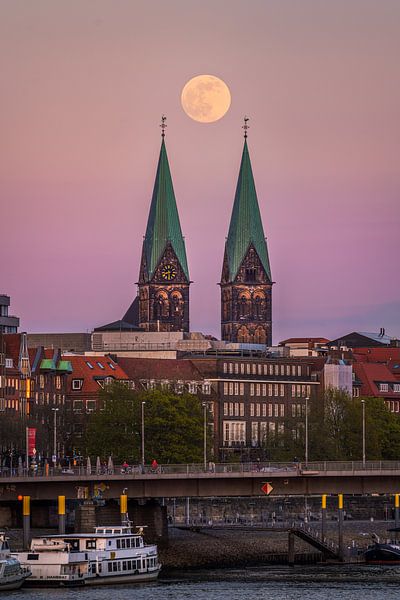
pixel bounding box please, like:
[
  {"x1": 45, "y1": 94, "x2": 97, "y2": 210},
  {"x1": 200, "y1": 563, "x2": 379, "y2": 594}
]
[{"x1": 86, "y1": 383, "x2": 210, "y2": 464}]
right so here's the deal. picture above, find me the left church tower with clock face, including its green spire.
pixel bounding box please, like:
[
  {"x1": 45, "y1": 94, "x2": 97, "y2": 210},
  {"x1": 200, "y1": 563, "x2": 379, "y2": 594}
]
[{"x1": 138, "y1": 117, "x2": 190, "y2": 331}]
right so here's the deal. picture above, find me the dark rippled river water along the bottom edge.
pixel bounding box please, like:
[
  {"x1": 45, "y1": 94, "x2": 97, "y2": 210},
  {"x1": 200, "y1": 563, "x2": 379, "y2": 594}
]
[{"x1": 7, "y1": 565, "x2": 400, "y2": 600}]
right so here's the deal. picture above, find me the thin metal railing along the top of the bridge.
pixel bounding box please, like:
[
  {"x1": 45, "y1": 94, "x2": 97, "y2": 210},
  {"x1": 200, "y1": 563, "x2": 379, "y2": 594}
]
[{"x1": 0, "y1": 461, "x2": 400, "y2": 478}]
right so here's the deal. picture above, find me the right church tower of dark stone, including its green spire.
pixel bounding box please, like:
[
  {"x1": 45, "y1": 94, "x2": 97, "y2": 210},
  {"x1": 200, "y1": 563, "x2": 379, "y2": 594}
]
[{"x1": 220, "y1": 117, "x2": 273, "y2": 346}]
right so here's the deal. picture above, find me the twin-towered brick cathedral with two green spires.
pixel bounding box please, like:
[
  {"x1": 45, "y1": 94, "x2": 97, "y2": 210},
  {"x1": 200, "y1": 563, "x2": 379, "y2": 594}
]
[{"x1": 97, "y1": 117, "x2": 273, "y2": 346}]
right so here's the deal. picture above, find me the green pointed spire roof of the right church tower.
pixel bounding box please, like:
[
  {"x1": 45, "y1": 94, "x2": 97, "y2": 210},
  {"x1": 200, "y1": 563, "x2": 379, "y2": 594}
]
[{"x1": 226, "y1": 139, "x2": 272, "y2": 280}]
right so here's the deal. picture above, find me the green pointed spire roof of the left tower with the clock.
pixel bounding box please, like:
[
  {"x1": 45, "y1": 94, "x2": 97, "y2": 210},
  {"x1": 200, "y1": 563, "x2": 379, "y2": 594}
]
[{"x1": 144, "y1": 138, "x2": 189, "y2": 279}]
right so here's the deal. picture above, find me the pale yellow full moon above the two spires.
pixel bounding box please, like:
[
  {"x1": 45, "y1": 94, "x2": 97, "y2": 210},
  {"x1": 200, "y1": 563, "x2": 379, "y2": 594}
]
[{"x1": 181, "y1": 75, "x2": 231, "y2": 123}]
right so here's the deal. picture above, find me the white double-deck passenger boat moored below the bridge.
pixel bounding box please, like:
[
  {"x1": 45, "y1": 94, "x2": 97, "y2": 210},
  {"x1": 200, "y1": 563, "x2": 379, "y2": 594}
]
[{"x1": 17, "y1": 523, "x2": 161, "y2": 585}]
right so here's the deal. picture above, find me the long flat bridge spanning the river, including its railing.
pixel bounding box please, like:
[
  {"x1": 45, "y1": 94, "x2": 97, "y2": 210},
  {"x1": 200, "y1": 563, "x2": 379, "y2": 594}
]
[{"x1": 0, "y1": 461, "x2": 400, "y2": 503}]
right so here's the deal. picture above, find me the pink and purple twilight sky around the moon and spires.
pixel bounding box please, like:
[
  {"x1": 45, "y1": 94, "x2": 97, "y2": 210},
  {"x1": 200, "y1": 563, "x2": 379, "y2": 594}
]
[{"x1": 0, "y1": 0, "x2": 400, "y2": 343}]
